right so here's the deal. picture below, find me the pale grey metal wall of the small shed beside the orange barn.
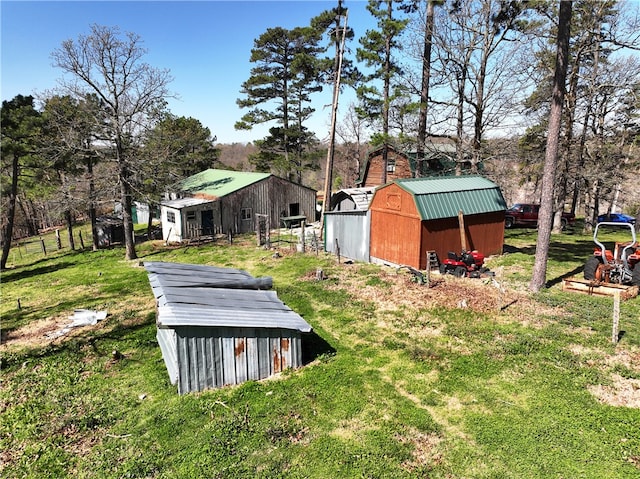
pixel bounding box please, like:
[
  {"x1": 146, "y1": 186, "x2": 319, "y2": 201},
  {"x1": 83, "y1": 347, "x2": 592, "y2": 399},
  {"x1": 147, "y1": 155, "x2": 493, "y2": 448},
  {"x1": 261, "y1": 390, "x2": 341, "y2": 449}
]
[{"x1": 324, "y1": 211, "x2": 371, "y2": 263}]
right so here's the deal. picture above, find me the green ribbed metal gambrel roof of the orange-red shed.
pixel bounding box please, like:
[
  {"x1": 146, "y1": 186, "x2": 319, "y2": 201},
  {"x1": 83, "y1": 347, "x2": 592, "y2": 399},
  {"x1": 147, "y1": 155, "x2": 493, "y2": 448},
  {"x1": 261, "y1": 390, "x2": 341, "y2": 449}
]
[{"x1": 394, "y1": 176, "x2": 507, "y2": 220}]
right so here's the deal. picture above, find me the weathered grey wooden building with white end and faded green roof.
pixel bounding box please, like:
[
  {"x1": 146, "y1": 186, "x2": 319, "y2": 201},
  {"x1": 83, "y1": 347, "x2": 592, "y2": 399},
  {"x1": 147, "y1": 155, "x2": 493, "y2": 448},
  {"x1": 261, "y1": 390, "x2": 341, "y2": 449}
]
[{"x1": 161, "y1": 169, "x2": 316, "y2": 242}]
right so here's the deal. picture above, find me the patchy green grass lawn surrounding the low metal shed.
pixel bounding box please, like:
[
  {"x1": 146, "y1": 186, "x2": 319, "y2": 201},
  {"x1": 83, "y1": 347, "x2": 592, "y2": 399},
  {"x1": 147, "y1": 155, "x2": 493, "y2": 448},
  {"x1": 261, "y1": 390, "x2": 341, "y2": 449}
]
[{"x1": 0, "y1": 229, "x2": 640, "y2": 479}]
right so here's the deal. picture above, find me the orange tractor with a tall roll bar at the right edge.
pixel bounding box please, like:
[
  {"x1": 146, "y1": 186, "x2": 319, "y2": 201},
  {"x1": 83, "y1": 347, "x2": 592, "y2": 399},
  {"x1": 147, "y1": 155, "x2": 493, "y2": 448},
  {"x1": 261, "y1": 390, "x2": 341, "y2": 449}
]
[{"x1": 584, "y1": 221, "x2": 640, "y2": 286}]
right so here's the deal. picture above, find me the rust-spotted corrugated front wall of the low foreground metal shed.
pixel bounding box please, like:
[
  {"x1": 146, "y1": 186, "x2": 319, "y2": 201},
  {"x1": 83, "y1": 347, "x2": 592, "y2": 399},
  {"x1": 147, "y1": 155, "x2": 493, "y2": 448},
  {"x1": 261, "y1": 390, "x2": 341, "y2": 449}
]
[{"x1": 170, "y1": 326, "x2": 302, "y2": 394}]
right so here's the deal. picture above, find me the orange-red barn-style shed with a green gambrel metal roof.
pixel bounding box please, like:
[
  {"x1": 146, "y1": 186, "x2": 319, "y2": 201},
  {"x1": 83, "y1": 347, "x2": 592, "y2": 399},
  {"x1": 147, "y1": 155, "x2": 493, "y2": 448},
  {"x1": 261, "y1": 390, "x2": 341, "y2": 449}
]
[{"x1": 370, "y1": 175, "x2": 506, "y2": 270}]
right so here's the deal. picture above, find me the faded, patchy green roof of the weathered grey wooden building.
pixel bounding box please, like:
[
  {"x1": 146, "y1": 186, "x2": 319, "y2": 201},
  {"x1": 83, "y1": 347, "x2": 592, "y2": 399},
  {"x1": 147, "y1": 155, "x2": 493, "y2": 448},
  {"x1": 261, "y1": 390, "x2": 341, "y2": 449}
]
[{"x1": 179, "y1": 169, "x2": 271, "y2": 198}]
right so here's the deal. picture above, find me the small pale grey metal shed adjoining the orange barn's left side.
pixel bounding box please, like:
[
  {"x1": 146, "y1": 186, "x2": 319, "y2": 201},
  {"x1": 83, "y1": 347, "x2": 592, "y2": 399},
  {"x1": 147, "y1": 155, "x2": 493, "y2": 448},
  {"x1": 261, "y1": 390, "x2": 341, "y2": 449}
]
[{"x1": 324, "y1": 188, "x2": 375, "y2": 263}]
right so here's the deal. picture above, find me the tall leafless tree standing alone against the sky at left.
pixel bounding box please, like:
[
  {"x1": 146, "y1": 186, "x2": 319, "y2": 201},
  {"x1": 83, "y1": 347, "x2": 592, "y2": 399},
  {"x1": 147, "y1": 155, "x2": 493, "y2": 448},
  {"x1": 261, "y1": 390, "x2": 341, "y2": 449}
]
[{"x1": 52, "y1": 25, "x2": 171, "y2": 259}]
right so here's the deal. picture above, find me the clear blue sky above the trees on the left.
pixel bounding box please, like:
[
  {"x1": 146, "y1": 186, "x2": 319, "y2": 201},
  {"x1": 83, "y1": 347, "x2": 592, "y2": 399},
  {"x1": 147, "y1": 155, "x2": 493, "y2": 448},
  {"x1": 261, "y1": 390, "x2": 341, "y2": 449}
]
[{"x1": 0, "y1": 0, "x2": 373, "y2": 143}]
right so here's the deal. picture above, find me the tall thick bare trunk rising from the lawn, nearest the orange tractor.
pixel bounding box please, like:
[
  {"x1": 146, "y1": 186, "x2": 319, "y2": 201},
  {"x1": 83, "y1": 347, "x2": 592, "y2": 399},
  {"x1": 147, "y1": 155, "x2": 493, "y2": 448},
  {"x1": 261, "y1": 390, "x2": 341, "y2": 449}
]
[{"x1": 529, "y1": 0, "x2": 572, "y2": 292}]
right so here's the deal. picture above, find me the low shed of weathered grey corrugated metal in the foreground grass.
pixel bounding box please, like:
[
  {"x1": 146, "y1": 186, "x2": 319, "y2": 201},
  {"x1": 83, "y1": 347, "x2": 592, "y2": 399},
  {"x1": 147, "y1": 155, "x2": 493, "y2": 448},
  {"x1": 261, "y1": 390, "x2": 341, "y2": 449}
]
[{"x1": 144, "y1": 262, "x2": 311, "y2": 394}]
